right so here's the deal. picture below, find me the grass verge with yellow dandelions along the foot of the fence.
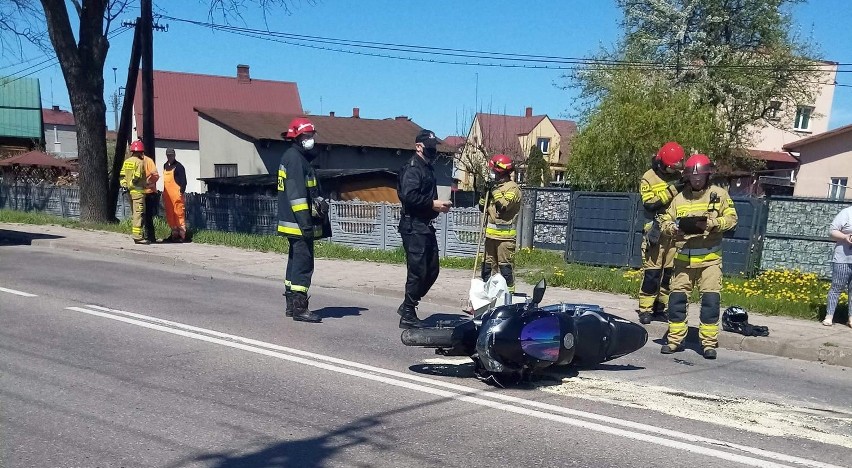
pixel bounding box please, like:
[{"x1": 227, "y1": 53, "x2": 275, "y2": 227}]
[{"x1": 0, "y1": 210, "x2": 836, "y2": 320}]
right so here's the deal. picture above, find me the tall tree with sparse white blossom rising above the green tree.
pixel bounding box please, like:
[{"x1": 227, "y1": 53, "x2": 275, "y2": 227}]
[{"x1": 571, "y1": 0, "x2": 826, "y2": 171}]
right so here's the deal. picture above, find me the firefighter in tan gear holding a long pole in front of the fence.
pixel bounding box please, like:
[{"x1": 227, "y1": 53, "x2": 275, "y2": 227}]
[{"x1": 479, "y1": 154, "x2": 521, "y2": 293}]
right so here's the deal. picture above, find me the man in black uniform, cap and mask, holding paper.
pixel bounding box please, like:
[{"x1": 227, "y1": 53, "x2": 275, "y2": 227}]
[{"x1": 397, "y1": 130, "x2": 452, "y2": 328}]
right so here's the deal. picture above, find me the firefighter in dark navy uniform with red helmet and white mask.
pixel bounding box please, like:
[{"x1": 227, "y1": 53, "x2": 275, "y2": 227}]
[{"x1": 278, "y1": 117, "x2": 331, "y2": 323}]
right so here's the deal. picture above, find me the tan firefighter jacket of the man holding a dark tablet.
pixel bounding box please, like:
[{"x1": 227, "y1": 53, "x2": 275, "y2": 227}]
[{"x1": 661, "y1": 185, "x2": 737, "y2": 268}]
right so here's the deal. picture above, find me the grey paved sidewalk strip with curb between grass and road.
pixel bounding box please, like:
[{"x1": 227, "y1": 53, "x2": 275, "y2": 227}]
[{"x1": 4, "y1": 232, "x2": 852, "y2": 367}]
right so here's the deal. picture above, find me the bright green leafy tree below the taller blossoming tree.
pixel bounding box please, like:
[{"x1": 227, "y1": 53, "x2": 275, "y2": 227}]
[{"x1": 567, "y1": 69, "x2": 719, "y2": 191}]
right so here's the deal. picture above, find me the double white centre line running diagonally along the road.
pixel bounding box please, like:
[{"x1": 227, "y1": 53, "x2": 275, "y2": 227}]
[{"x1": 66, "y1": 305, "x2": 840, "y2": 468}]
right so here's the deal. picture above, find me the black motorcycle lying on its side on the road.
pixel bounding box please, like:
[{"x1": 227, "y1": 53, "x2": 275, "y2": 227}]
[{"x1": 401, "y1": 280, "x2": 648, "y2": 388}]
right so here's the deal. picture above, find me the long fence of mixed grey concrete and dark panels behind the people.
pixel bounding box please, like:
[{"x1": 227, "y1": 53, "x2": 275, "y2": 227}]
[{"x1": 0, "y1": 183, "x2": 847, "y2": 277}]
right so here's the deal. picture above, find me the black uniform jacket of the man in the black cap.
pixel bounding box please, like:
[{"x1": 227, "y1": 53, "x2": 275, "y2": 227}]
[{"x1": 396, "y1": 154, "x2": 438, "y2": 234}]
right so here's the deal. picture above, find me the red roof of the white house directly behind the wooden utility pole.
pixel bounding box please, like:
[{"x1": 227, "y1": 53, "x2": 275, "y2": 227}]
[{"x1": 133, "y1": 70, "x2": 302, "y2": 141}]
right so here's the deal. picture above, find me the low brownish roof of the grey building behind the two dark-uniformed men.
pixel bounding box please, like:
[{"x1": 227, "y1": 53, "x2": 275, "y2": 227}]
[{"x1": 196, "y1": 108, "x2": 455, "y2": 153}]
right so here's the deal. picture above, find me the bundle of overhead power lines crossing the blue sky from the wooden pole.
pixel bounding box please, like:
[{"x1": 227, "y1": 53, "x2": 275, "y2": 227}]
[{"x1": 162, "y1": 15, "x2": 852, "y2": 73}]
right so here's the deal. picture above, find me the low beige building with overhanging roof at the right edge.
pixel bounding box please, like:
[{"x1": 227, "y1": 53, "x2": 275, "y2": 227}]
[{"x1": 784, "y1": 125, "x2": 852, "y2": 200}]
